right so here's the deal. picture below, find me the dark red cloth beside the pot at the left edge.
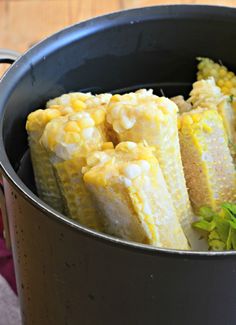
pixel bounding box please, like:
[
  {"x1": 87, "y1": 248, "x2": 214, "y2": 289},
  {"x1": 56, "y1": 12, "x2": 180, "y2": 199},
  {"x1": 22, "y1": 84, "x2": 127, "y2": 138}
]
[{"x1": 0, "y1": 214, "x2": 17, "y2": 293}]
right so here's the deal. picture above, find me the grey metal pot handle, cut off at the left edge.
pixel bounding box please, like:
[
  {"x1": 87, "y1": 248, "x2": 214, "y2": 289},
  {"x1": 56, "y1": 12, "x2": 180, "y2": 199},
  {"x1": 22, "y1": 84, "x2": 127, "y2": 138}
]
[{"x1": 0, "y1": 48, "x2": 20, "y2": 248}]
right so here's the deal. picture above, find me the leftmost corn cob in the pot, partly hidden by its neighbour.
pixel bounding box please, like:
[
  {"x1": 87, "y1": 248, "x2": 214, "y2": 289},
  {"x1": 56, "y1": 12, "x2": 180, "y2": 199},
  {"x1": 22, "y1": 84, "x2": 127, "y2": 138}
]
[{"x1": 26, "y1": 109, "x2": 64, "y2": 212}]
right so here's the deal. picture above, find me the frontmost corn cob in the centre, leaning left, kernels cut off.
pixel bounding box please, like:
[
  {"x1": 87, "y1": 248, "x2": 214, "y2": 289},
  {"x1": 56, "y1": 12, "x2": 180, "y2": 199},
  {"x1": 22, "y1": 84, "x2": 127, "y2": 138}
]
[{"x1": 83, "y1": 142, "x2": 188, "y2": 249}]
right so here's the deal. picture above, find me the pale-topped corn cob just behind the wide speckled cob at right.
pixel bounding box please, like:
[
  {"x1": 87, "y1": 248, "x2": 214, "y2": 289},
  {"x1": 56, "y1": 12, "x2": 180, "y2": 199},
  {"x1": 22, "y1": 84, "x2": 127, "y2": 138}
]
[{"x1": 188, "y1": 77, "x2": 236, "y2": 143}]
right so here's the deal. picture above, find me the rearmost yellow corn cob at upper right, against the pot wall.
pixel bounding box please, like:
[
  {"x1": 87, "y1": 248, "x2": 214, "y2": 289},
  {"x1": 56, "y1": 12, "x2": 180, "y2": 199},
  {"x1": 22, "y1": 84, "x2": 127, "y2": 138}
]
[{"x1": 197, "y1": 58, "x2": 236, "y2": 96}]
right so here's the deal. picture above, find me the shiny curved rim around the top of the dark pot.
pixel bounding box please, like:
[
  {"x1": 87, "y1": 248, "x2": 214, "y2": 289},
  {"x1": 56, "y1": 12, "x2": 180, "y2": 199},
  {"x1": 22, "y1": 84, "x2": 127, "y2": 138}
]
[{"x1": 0, "y1": 4, "x2": 236, "y2": 257}]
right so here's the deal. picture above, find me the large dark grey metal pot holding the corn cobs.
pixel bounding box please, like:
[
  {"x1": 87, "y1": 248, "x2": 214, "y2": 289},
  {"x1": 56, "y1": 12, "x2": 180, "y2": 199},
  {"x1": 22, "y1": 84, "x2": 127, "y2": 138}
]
[{"x1": 0, "y1": 6, "x2": 236, "y2": 325}]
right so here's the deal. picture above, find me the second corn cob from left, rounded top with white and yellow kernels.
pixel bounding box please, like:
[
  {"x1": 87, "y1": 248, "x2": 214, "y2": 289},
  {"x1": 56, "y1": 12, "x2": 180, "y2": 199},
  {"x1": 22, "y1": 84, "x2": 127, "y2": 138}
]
[{"x1": 41, "y1": 108, "x2": 109, "y2": 229}]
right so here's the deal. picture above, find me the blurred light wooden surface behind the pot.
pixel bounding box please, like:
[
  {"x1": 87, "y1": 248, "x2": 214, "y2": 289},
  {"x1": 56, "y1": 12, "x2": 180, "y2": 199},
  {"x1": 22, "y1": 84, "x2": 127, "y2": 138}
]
[{"x1": 0, "y1": 0, "x2": 236, "y2": 52}]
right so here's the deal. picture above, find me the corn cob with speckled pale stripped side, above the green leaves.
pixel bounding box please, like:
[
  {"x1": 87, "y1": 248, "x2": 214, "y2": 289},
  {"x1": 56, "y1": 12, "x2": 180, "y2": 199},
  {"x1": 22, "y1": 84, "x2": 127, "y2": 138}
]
[{"x1": 179, "y1": 108, "x2": 236, "y2": 211}]
